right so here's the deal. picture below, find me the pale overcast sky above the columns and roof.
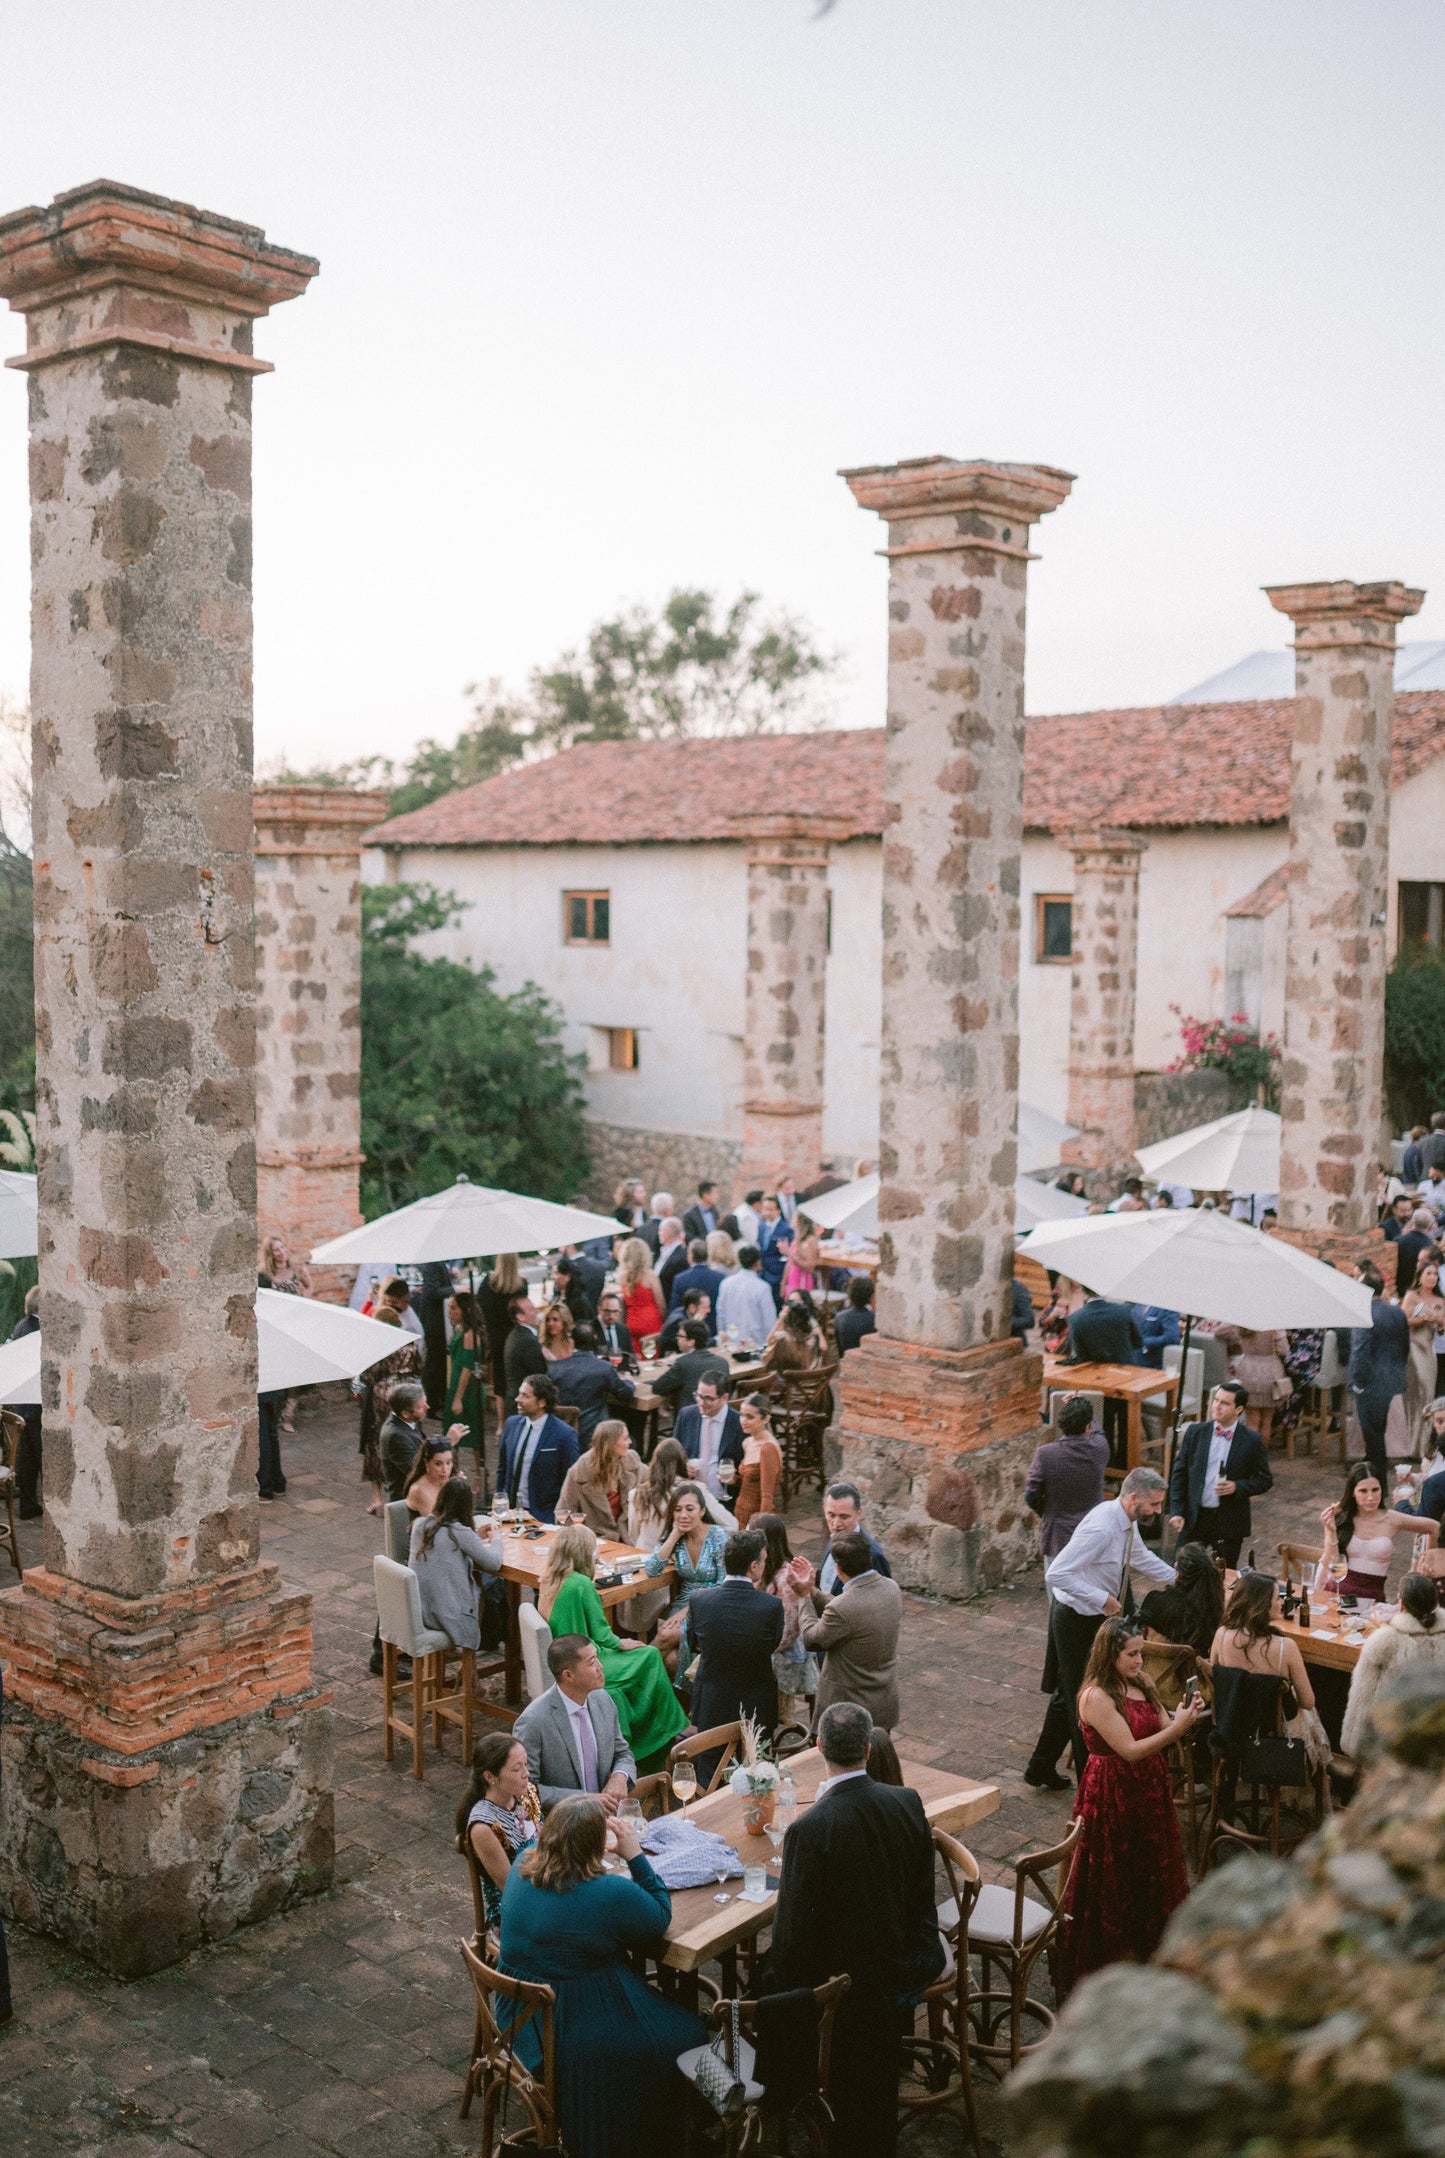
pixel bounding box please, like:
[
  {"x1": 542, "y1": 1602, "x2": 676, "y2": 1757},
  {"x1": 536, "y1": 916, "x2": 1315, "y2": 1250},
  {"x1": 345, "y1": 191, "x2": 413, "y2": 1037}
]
[{"x1": 0, "y1": 0, "x2": 1445, "y2": 764}]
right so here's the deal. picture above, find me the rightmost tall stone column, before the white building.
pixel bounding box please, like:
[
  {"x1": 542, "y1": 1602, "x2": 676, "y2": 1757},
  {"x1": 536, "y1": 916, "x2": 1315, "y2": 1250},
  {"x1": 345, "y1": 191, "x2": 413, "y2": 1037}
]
[{"x1": 1266, "y1": 581, "x2": 1426, "y2": 1260}]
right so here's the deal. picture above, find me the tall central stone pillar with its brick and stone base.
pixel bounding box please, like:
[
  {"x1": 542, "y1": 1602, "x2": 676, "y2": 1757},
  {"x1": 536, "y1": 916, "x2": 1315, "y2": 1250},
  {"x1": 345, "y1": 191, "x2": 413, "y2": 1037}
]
[{"x1": 832, "y1": 457, "x2": 1072, "y2": 1595}]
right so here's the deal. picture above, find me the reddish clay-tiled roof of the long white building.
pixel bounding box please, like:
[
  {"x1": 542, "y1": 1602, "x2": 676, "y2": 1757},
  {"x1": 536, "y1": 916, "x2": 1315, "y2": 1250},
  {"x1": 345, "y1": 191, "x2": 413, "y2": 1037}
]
[{"x1": 367, "y1": 691, "x2": 1445, "y2": 846}]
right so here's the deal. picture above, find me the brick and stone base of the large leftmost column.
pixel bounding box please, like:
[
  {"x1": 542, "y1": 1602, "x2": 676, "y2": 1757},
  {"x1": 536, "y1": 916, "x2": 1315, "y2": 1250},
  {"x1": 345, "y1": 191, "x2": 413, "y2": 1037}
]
[{"x1": 0, "y1": 1565, "x2": 334, "y2": 1979}]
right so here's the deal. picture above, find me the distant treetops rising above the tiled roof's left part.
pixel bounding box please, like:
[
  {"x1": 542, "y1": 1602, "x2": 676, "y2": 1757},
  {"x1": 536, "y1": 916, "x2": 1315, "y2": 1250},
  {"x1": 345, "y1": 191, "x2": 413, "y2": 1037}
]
[{"x1": 270, "y1": 585, "x2": 837, "y2": 816}]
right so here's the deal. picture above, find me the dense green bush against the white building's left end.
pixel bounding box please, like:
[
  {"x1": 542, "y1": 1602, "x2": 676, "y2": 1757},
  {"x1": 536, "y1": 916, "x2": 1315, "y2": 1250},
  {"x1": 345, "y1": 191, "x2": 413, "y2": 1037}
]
[{"x1": 362, "y1": 885, "x2": 587, "y2": 1217}]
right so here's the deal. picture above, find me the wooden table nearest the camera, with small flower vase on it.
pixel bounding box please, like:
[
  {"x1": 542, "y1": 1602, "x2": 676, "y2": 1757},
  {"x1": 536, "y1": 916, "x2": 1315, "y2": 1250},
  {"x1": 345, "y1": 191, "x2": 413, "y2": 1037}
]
[{"x1": 662, "y1": 1746, "x2": 999, "y2": 1994}]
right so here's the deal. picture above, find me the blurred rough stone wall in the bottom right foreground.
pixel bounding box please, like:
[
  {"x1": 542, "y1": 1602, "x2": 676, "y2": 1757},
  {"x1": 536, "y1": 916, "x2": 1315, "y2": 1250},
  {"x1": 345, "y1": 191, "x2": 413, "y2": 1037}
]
[{"x1": 1007, "y1": 1664, "x2": 1445, "y2": 2158}]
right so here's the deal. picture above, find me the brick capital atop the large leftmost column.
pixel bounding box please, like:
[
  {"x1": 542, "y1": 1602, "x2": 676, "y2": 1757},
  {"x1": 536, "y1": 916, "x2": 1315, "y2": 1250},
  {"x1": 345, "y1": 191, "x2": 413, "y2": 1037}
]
[{"x1": 0, "y1": 179, "x2": 319, "y2": 373}]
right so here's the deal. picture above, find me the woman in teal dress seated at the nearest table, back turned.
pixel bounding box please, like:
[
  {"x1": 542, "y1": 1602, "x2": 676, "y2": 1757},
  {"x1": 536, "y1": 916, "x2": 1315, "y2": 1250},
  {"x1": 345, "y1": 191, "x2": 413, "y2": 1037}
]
[{"x1": 500, "y1": 1786, "x2": 707, "y2": 2158}]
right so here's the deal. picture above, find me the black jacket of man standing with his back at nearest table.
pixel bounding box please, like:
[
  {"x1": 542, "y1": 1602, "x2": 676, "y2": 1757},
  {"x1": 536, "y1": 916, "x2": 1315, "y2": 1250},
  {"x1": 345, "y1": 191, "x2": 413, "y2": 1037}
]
[{"x1": 776, "y1": 1769, "x2": 945, "y2": 2002}]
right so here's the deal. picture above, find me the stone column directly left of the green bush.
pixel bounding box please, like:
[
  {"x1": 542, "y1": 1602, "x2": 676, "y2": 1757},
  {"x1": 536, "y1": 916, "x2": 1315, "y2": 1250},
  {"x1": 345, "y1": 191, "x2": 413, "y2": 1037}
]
[{"x1": 254, "y1": 786, "x2": 386, "y2": 1303}]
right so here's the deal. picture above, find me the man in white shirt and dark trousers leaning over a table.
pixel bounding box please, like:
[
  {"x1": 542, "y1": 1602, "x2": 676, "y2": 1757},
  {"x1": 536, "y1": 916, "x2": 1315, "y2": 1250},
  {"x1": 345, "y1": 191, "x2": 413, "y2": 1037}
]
[{"x1": 1024, "y1": 1470, "x2": 1173, "y2": 1791}]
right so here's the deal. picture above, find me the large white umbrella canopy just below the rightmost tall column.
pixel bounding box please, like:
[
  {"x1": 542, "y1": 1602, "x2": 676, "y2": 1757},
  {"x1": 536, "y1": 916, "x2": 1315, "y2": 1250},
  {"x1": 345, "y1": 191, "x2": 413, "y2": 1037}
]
[{"x1": 1020, "y1": 1206, "x2": 1370, "y2": 1327}]
